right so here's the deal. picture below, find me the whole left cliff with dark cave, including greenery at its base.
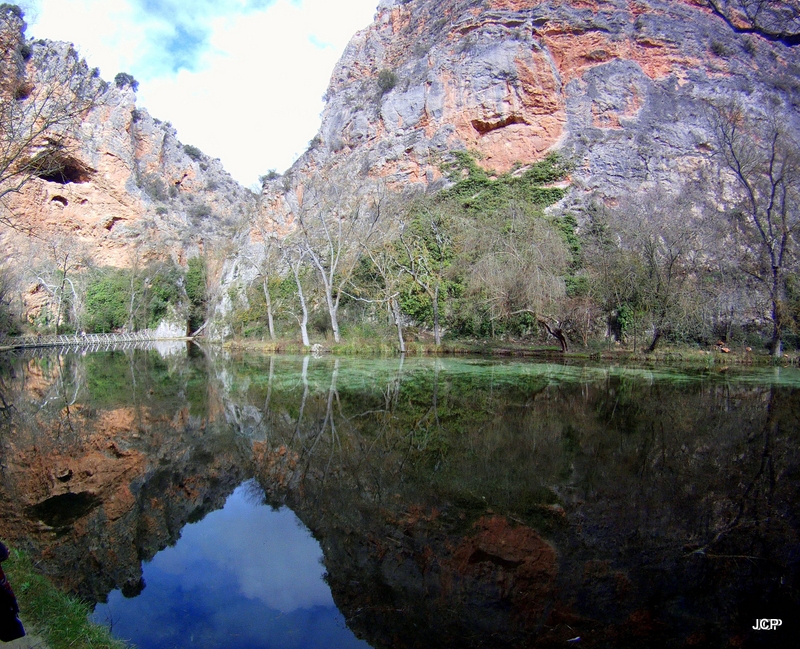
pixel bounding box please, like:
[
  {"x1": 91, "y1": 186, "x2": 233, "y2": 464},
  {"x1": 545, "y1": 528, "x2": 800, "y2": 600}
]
[{"x1": 0, "y1": 4, "x2": 255, "y2": 340}]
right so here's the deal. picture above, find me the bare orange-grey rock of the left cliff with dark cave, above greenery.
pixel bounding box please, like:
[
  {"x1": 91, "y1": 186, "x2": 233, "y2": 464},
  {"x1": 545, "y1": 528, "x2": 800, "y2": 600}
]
[{"x1": 0, "y1": 13, "x2": 254, "y2": 267}]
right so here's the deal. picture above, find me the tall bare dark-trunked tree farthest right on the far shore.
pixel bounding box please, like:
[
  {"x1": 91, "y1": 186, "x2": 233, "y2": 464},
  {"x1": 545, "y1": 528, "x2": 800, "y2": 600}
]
[{"x1": 709, "y1": 104, "x2": 800, "y2": 357}]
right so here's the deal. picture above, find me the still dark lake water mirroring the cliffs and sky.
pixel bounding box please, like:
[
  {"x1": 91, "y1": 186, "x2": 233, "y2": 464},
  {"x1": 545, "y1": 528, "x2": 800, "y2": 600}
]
[{"x1": 0, "y1": 347, "x2": 800, "y2": 649}]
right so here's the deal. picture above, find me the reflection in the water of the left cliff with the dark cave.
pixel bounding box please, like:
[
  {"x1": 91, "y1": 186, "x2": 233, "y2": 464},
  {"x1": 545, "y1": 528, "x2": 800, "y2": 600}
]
[{"x1": 0, "y1": 352, "x2": 253, "y2": 601}]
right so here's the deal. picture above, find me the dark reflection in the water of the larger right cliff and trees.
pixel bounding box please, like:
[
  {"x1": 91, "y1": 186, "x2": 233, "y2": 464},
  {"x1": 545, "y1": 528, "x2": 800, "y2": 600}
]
[{"x1": 239, "y1": 361, "x2": 800, "y2": 647}]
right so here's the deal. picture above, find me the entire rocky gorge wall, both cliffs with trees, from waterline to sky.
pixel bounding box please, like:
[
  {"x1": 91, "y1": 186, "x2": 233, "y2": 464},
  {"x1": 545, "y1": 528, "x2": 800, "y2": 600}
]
[{"x1": 0, "y1": 0, "x2": 800, "y2": 355}]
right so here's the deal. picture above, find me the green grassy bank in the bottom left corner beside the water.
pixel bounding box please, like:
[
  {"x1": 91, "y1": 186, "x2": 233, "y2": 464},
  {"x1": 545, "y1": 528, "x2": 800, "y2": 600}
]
[{"x1": 5, "y1": 550, "x2": 129, "y2": 649}]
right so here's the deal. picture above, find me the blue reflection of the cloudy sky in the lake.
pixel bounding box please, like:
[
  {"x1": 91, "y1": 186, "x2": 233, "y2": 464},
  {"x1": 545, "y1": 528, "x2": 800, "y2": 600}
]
[{"x1": 93, "y1": 485, "x2": 368, "y2": 649}]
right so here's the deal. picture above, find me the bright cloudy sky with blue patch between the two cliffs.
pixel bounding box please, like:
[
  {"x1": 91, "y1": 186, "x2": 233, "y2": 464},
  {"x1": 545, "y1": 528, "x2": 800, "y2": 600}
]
[{"x1": 18, "y1": 0, "x2": 378, "y2": 186}]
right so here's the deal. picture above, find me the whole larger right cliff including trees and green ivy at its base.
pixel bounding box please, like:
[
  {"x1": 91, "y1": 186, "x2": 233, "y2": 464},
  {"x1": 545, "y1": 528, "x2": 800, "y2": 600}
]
[{"x1": 223, "y1": 0, "x2": 800, "y2": 354}]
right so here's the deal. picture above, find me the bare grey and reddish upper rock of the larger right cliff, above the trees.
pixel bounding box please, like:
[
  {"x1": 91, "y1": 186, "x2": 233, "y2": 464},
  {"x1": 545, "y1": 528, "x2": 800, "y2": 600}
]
[{"x1": 263, "y1": 0, "x2": 800, "y2": 221}]
